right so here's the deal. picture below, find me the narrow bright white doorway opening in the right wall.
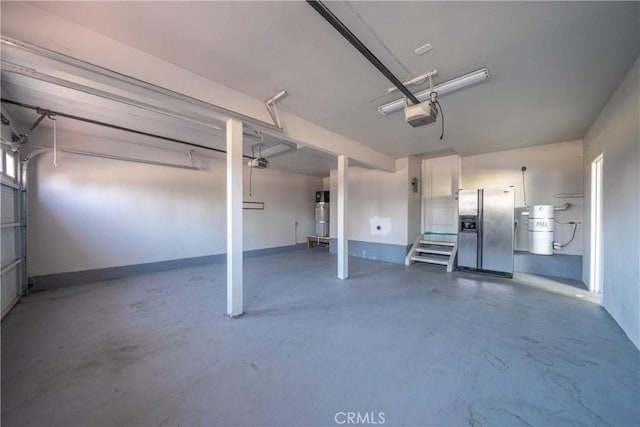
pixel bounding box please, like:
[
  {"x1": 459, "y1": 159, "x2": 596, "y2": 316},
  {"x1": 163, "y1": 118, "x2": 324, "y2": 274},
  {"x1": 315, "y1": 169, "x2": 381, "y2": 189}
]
[{"x1": 589, "y1": 154, "x2": 604, "y2": 293}]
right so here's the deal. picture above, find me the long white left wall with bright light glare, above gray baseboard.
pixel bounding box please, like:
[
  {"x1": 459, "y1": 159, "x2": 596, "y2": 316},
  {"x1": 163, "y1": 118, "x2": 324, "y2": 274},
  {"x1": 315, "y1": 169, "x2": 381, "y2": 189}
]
[{"x1": 28, "y1": 134, "x2": 322, "y2": 276}]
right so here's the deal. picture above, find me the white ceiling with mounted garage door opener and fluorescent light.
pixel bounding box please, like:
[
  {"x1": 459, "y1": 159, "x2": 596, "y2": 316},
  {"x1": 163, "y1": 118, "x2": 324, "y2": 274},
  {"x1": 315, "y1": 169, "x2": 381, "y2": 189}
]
[{"x1": 1, "y1": 1, "x2": 640, "y2": 167}]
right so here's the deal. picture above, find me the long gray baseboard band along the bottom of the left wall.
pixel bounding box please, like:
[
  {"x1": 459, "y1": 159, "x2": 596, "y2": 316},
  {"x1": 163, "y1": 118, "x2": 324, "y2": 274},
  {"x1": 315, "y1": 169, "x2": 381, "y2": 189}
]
[{"x1": 30, "y1": 243, "x2": 307, "y2": 290}]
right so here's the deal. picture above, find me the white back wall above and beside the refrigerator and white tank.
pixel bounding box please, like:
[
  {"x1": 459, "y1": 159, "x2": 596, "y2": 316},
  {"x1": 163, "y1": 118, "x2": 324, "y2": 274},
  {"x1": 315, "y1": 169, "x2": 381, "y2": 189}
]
[{"x1": 461, "y1": 140, "x2": 584, "y2": 255}]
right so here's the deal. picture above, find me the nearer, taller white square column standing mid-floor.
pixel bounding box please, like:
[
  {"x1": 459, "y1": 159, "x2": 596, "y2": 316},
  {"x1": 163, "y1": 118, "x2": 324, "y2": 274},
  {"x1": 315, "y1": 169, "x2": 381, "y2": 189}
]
[{"x1": 227, "y1": 119, "x2": 243, "y2": 317}]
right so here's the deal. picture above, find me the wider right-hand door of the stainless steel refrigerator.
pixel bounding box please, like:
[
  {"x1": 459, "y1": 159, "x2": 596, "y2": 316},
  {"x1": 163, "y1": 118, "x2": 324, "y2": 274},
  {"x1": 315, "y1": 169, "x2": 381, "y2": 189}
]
[{"x1": 480, "y1": 188, "x2": 514, "y2": 274}]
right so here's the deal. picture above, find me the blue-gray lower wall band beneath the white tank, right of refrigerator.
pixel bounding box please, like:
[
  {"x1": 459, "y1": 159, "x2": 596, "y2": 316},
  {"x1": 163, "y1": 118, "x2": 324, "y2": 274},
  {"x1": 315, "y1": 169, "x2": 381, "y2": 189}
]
[{"x1": 513, "y1": 251, "x2": 582, "y2": 281}]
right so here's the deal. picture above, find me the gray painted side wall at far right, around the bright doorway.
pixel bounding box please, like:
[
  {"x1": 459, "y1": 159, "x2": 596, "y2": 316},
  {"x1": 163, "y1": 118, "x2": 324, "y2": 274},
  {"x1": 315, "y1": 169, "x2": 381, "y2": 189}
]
[{"x1": 583, "y1": 58, "x2": 640, "y2": 348}]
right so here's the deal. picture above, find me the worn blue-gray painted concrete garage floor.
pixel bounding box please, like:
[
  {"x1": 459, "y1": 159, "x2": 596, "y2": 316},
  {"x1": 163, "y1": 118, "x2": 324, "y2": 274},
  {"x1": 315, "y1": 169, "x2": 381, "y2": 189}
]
[{"x1": 2, "y1": 248, "x2": 640, "y2": 427}]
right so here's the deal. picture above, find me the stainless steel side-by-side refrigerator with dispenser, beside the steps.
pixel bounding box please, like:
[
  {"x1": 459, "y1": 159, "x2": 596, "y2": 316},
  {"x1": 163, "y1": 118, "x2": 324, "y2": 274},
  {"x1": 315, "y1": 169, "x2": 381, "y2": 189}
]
[{"x1": 458, "y1": 188, "x2": 514, "y2": 277}]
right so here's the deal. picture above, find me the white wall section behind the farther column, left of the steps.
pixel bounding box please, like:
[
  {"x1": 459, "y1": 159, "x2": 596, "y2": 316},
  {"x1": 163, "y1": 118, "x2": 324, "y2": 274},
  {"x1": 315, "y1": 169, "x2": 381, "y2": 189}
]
[{"x1": 330, "y1": 158, "x2": 420, "y2": 246}]
